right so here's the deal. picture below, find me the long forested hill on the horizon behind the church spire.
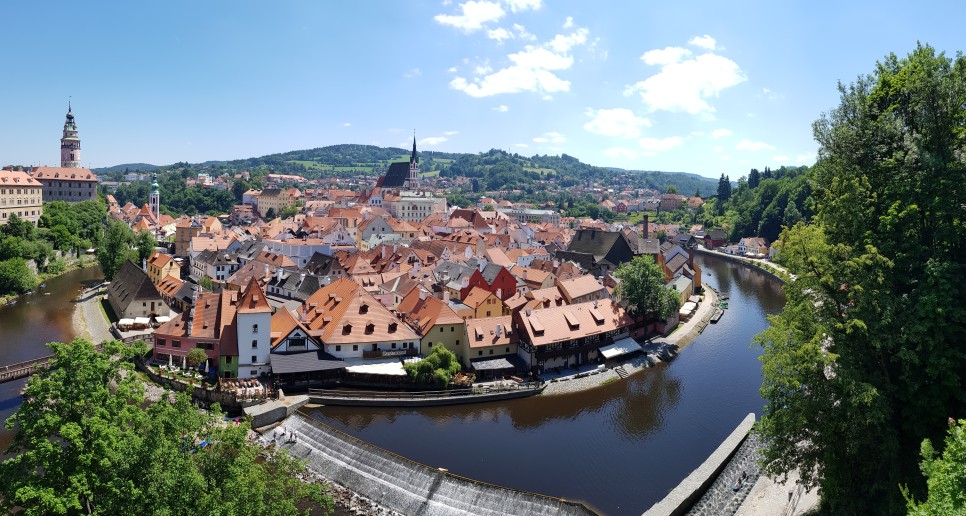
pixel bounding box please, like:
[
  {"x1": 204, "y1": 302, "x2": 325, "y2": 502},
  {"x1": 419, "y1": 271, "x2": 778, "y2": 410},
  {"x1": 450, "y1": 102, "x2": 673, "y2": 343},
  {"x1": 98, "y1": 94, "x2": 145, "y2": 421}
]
[{"x1": 95, "y1": 144, "x2": 717, "y2": 196}]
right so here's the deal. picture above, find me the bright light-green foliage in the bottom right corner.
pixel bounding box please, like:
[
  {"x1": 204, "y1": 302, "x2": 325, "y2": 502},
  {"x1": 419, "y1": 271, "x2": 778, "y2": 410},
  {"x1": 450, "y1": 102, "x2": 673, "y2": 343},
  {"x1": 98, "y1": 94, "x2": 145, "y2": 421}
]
[{"x1": 903, "y1": 418, "x2": 966, "y2": 516}]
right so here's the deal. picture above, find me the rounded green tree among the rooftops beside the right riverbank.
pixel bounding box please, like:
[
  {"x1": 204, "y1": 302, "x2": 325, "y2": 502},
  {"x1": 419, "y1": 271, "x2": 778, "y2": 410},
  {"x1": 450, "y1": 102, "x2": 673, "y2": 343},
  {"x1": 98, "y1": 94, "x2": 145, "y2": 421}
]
[{"x1": 614, "y1": 255, "x2": 681, "y2": 320}]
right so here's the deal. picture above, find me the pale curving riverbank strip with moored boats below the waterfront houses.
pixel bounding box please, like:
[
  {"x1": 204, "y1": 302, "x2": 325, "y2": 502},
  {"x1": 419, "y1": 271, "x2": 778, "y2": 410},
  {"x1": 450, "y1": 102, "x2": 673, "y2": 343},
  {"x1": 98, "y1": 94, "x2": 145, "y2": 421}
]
[{"x1": 540, "y1": 287, "x2": 718, "y2": 396}]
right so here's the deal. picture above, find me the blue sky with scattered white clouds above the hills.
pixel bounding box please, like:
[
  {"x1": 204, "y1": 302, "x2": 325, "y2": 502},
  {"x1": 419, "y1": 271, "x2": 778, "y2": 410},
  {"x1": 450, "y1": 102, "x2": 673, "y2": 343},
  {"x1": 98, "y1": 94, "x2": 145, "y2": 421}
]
[{"x1": 0, "y1": 0, "x2": 966, "y2": 179}]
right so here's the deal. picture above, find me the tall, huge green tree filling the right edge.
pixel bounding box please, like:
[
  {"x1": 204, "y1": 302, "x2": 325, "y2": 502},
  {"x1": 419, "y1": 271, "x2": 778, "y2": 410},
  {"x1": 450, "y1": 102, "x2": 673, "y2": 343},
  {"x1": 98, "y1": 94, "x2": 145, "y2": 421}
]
[{"x1": 758, "y1": 45, "x2": 966, "y2": 514}]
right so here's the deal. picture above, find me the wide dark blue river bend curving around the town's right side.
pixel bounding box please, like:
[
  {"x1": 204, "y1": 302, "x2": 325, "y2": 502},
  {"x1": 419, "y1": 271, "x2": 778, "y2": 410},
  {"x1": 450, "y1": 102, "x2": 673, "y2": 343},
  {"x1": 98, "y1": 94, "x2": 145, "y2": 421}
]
[{"x1": 314, "y1": 256, "x2": 784, "y2": 515}]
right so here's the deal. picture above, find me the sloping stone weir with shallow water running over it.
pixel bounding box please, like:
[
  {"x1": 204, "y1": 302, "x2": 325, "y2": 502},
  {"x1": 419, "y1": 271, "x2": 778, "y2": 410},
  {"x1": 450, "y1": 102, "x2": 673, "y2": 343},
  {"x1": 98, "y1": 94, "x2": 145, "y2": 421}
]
[{"x1": 282, "y1": 411, "x2": 596, "y2": 516}]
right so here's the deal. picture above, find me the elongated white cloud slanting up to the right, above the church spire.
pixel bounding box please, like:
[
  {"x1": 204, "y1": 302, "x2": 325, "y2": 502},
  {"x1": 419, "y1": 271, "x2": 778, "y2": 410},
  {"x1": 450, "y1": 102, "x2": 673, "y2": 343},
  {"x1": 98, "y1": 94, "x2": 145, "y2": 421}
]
[{"x1": 449, "y1": 28, "x2": 587, "y2": 98}]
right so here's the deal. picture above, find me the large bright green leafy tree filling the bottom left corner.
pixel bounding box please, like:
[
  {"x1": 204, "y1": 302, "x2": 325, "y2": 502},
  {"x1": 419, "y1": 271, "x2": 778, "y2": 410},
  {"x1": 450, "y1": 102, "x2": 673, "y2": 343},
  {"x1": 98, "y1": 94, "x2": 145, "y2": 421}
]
[{"x1": 0, "y1": 339, "x2": 331, "y2": 515}]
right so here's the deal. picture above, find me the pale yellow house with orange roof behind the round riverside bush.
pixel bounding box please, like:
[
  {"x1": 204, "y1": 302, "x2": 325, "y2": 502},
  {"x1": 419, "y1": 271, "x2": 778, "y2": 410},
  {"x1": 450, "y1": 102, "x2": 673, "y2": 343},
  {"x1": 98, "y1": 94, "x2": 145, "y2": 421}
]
[{"x1": 397, "y1": 286, "x2": 466, "y2": 362}]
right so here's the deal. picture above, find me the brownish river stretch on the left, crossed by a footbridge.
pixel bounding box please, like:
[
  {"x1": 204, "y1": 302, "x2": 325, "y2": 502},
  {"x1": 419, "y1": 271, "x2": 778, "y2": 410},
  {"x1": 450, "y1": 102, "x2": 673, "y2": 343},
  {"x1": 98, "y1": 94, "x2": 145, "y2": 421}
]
[{"x1": 0, "y1": 267, "x2": 104, "y2": 453}]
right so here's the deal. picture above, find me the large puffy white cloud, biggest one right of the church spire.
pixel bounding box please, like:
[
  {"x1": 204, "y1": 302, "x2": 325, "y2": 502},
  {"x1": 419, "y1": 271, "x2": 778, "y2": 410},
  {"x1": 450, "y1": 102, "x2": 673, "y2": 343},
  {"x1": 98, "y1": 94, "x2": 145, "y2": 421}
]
[{"x1": 624, "y1": 47, "x2": 747, "y2": 116}]
